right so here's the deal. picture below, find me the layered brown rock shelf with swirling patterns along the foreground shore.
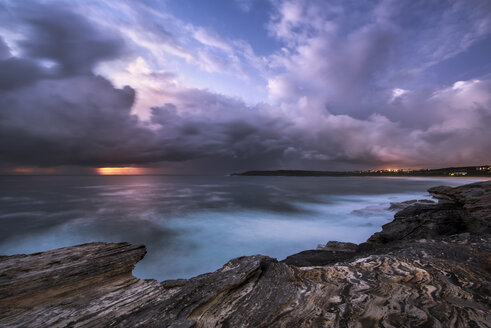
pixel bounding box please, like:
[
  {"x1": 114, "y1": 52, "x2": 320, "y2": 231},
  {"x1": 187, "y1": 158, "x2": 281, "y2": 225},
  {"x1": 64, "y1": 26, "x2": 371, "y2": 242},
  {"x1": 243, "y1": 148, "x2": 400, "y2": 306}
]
[{"x1": 0, "y1": 181, "x2": 491, "y2": 328}]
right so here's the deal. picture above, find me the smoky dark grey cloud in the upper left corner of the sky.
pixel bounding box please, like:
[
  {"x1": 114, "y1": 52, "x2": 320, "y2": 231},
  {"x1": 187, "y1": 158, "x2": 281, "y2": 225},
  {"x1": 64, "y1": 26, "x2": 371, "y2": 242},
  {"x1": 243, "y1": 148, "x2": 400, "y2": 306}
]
[{"x1": 0, "y1": 2, "x2": 124, "y2": 90}]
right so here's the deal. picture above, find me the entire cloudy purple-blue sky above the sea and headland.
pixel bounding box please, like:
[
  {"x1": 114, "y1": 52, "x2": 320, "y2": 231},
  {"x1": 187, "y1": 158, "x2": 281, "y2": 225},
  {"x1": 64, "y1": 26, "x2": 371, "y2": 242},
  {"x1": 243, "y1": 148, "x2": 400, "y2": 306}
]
[{"x1": 0, "y1": 0, "x2": 491, "y2": 174}]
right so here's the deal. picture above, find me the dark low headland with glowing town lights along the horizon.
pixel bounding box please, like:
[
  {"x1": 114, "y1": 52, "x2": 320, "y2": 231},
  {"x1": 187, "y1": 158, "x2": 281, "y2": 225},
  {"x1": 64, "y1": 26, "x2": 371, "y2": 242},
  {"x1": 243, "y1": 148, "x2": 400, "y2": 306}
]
[{"x1": 231, "y1": 165, "x2": 491, "y2": 178}]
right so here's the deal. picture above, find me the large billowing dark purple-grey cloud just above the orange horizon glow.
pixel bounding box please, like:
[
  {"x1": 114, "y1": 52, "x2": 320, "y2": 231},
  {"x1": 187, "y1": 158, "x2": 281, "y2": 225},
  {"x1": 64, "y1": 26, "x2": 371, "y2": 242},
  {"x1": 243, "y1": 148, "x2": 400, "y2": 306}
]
[{"x1": 0, "y1": 76, "x2": 157, "y2": 166}]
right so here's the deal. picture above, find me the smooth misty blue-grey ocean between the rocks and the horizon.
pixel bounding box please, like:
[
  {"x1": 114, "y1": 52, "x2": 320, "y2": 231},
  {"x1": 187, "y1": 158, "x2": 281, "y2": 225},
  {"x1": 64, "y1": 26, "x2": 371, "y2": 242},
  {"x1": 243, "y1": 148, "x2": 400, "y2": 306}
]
[{"x1": 0, "y1": 176, "x2": 473, "y2": 281}]
